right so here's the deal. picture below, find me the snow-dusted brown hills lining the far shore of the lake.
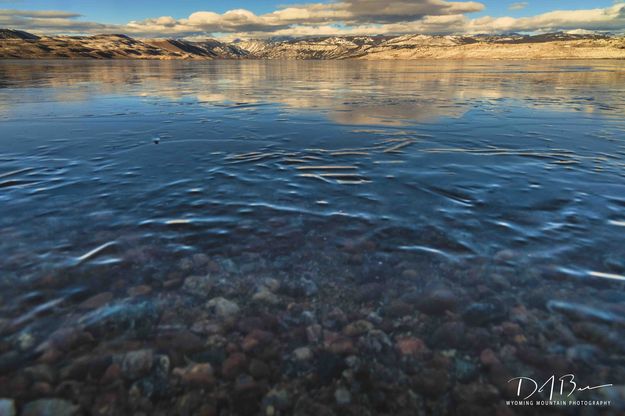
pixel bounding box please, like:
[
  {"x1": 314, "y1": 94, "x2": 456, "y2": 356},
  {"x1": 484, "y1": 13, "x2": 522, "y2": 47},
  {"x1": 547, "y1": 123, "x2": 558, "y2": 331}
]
[{"x1": 0, "y1": 29, "x2": 625, "y2": 60}]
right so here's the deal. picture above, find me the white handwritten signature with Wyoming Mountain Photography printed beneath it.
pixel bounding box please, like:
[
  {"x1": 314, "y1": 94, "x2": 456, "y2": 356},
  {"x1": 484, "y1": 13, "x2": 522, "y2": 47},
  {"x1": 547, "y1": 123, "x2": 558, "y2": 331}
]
[{"x1": 508, "y1": 374, "x2": 613, "y2": 406}]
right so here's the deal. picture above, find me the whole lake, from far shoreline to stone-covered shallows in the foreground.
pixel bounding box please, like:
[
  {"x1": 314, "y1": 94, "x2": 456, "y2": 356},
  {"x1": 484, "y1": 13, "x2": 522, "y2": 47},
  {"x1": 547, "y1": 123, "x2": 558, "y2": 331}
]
[{"x1": 0, "y1": 61, "x2": 625, "y2": 415}]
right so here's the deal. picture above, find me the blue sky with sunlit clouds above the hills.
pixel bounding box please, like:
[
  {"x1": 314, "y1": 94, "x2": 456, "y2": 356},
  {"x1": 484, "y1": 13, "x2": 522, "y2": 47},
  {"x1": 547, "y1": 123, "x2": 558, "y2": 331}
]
[{"x1": 0, "y1": 0, "x2": 625, "y2": 38}]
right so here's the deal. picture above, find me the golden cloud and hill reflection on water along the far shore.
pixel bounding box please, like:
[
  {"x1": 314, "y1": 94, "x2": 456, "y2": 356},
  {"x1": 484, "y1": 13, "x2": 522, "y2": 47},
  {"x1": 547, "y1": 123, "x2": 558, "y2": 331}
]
[{"x1": 0, "y1": 61, "x2": 625, "y2": 125}]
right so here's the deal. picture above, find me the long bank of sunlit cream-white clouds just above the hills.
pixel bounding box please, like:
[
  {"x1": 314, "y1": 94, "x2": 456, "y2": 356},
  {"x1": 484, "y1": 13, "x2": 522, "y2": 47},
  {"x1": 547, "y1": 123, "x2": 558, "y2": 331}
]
[{"x1": 0, "y1": 0, "x2": 625, "y2": 38}]
